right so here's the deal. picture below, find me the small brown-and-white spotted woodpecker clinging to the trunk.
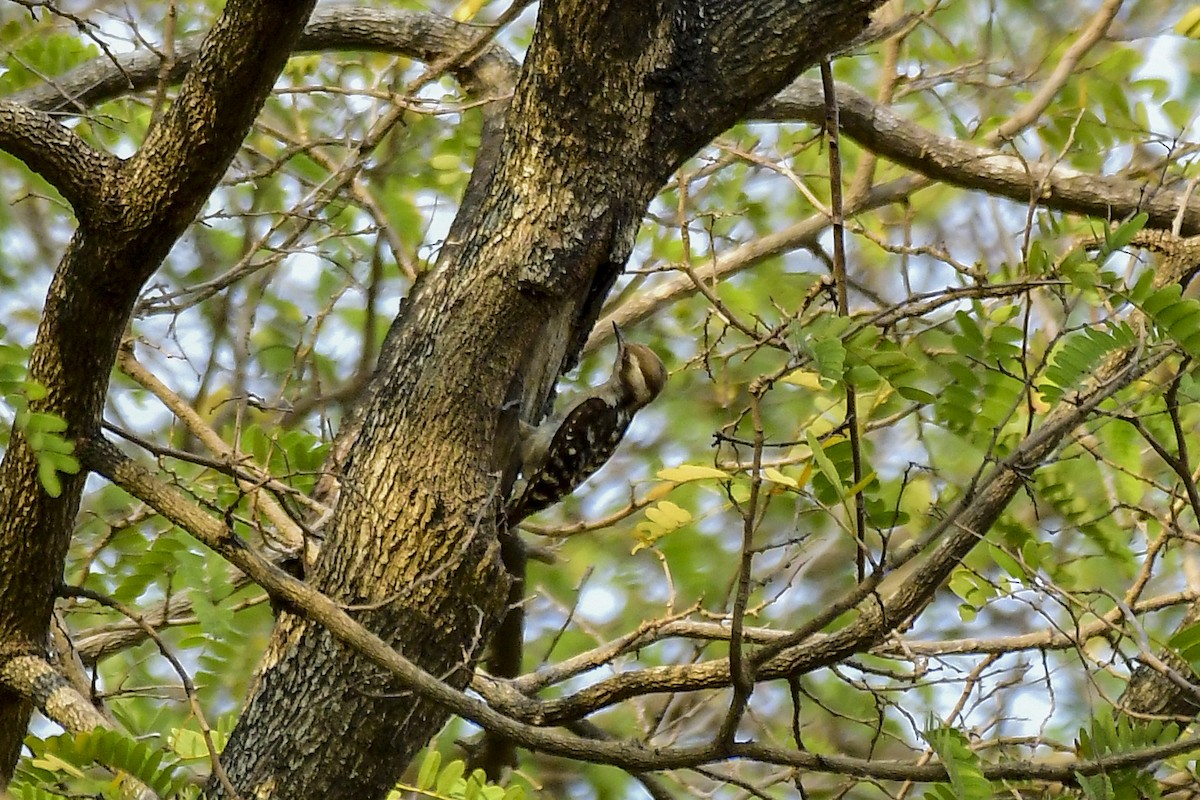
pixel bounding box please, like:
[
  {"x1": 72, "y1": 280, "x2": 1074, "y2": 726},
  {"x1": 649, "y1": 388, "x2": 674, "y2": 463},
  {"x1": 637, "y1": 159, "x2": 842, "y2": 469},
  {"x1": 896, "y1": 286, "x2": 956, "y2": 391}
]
[{"x1": 508, "y1": 323, "x2": 667, "y2": 524}]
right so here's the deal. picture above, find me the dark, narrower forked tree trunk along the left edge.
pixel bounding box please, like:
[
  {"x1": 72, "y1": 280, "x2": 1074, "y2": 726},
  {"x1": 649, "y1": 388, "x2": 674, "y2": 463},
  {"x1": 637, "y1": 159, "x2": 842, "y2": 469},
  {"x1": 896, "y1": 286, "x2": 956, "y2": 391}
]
[{"x1": 0, "y1": 0, "x2": 312, "y2": 784}]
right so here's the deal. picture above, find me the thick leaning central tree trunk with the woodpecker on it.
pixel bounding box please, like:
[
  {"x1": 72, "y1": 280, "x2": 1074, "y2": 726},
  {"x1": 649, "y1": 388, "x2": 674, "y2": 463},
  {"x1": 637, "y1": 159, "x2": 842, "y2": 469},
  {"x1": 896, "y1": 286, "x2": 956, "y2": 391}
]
[{"x1": 206, "y1": 1, "x2": 877, "y2": 798}]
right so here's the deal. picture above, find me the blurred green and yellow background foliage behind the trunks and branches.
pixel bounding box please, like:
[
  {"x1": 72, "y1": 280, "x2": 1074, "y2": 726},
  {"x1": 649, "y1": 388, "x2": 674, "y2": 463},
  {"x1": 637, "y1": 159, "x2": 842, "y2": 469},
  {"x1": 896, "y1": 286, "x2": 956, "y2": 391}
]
[{"x1": 7, "y1": 0, "x2": 1200, "y2": 798}]
